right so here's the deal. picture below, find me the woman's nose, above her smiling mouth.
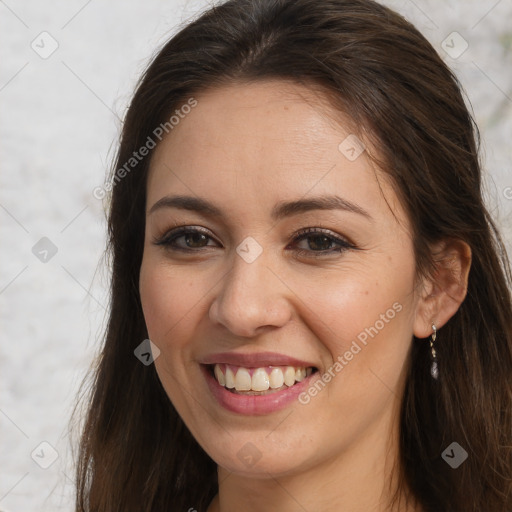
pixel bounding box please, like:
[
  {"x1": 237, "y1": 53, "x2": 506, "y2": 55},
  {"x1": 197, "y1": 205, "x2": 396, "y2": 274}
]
[{"x1": 209, "y1": 251, "x2": 292, "y2": 337}]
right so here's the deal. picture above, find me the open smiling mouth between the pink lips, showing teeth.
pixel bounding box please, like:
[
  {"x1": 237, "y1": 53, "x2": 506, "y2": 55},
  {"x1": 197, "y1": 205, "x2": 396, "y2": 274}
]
[{"x1": 208, "y1": 363, "x2": 318, "y2": 395}]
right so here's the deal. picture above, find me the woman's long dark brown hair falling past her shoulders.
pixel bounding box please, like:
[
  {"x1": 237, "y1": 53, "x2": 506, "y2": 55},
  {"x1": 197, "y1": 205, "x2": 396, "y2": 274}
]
[{"x1": 76, "y1": 0, "x2": 512, "y2": 512}]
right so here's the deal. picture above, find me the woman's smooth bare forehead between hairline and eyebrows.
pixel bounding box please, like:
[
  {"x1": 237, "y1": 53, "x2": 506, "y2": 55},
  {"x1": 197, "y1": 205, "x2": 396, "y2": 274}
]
[{"x1": 147, "y1": 81, "x2": 402, "y2": 228}]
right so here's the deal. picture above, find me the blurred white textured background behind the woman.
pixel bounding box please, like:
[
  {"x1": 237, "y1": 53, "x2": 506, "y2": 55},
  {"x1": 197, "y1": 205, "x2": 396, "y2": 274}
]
[{"x1": 0, "y1": 0, "x2": 512, "y2": 512}]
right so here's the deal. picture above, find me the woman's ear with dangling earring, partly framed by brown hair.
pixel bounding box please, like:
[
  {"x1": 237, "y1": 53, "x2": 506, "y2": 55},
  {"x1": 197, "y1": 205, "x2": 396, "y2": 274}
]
[{"x1": 413, "y1": 239, "x2": 471, "y2": 338}]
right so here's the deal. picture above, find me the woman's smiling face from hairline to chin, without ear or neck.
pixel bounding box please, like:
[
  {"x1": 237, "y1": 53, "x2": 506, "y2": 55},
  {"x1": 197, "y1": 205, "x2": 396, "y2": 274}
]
[{"x1": 140, "y1": 81, "x2": 419, "y2": 477}]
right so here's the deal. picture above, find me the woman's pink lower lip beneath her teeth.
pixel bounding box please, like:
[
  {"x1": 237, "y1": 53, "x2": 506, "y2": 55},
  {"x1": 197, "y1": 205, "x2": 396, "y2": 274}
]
[{"x1": 201, "y1": 365, "x2": 317, "y2": 416}]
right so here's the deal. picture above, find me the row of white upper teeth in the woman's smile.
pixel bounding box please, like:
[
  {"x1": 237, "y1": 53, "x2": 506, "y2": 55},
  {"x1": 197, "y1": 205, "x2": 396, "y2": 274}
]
[{"x1": 213, "y1": 364, "x2": 313, "y2": 391}]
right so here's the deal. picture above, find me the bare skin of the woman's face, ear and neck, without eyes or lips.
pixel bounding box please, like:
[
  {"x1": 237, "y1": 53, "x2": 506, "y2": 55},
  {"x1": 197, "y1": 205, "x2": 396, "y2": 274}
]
[{"x1": 140, "y1": 81, "x2": 470, "y2": 512}]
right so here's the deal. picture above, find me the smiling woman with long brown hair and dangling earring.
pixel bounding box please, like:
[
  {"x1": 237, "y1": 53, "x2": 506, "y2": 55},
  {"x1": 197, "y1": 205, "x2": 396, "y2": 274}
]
[{"x1": 76, "y1": 0, "x2": 512, "y2": 512}]
